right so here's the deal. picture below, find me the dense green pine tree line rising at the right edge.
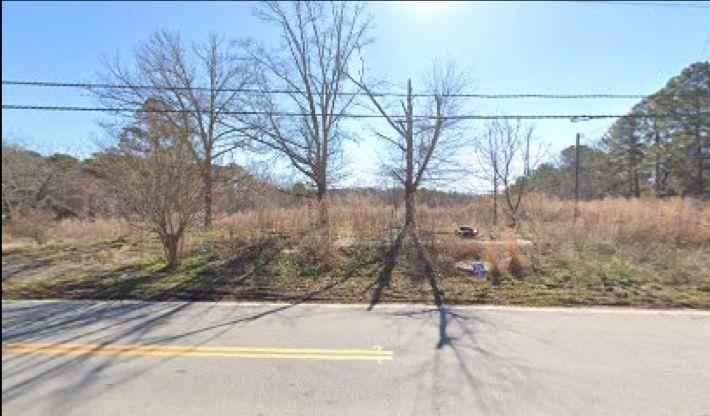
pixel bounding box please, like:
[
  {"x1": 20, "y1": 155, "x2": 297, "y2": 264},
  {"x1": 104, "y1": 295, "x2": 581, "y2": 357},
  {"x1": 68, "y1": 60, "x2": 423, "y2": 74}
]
[{"x1": 527, "y1": 62, "x2": 710, "y2": 199}]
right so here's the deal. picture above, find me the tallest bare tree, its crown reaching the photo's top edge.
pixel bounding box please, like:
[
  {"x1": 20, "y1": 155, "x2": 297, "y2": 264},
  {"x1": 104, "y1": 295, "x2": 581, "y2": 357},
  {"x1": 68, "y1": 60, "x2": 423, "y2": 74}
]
[{"x1": 246, "y1": 1, "x2": 370, "y2": 228}]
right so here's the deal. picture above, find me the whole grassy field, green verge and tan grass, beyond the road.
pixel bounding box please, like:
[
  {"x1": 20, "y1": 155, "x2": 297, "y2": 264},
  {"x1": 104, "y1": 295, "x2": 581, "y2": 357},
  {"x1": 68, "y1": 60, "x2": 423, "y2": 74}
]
[{"x1": 2, "y1": 196, "x2": 710, "y2": 308}]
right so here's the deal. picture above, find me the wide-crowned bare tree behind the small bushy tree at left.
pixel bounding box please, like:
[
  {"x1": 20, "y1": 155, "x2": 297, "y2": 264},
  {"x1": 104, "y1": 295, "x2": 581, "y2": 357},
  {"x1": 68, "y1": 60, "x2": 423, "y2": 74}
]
[{"x1": 92, "y1": 30, "x2": 253, "y2": 228}]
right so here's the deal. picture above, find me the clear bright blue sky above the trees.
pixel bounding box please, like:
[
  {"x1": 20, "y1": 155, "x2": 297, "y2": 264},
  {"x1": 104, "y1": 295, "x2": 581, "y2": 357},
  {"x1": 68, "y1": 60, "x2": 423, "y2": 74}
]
[{"x1": 2, "y1": 1, "x2": 710, "y2": 190}]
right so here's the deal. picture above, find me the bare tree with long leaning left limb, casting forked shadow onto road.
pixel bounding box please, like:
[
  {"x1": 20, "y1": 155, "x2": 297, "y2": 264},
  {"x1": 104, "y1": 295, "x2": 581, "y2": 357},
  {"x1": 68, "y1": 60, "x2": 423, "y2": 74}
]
[{"x1": 353, "y1": 62, "x2": 466, "y2": 229}]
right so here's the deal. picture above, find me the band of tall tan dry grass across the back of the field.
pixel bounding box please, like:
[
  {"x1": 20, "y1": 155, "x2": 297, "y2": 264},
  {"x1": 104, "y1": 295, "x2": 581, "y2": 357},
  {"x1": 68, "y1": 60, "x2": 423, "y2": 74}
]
[{"x1": 3, "y1": 195, "x2": 710, "y2": 257}]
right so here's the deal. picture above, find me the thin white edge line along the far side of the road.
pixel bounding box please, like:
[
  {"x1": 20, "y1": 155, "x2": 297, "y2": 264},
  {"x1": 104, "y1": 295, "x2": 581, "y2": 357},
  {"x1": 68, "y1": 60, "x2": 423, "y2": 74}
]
[{"x1": 2, "y1": 299, "x2": 710, "y2": 317}]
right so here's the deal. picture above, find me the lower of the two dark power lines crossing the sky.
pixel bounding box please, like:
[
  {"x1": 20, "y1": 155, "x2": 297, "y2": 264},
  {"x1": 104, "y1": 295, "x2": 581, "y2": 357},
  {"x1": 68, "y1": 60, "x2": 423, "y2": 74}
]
[{"x1": 2, "y1": 104, "x2": 706, "y2": 121}]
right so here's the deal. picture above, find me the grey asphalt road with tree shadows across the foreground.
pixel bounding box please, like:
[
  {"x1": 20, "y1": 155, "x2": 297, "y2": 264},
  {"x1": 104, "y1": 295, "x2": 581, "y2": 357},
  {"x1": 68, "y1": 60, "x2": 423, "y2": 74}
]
[{"x1": 2, "y1": 301, "x2": 710, "y2": 416}]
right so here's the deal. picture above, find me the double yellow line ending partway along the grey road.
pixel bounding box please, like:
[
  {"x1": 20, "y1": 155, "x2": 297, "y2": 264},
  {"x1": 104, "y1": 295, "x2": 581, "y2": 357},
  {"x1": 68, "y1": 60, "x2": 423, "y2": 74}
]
[{"x1": 2, "y1": 342, "x2": 392, "y2": 361}]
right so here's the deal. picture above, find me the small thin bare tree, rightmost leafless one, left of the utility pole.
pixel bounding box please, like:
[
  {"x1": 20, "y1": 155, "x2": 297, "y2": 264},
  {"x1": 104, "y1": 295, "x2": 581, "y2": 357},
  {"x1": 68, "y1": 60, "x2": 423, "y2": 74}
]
[{"x1": 475, "y1": 119, "x2": 539, "y2": 225}]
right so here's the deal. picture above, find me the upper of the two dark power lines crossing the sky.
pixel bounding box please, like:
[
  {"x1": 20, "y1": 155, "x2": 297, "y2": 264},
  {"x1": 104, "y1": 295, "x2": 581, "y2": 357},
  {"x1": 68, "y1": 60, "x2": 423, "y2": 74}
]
[{"x1": 2, "y1": 80, "x2": 710, "y2": 99}]
